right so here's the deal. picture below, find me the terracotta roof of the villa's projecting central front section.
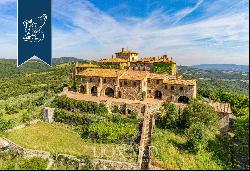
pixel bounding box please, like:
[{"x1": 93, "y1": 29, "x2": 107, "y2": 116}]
[{"x1": 119, "y1": 70, "x2": 149, "y2": 80}]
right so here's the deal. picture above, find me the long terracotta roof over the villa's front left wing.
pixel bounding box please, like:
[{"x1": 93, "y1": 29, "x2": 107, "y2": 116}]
[{"x1": 77, "y1": 68, "x2": 125, "y2": 78}]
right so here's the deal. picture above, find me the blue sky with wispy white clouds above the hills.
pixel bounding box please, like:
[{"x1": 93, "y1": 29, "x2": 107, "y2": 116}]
[{"x1": 0, "y1": 0, "x2": 249, "y2": 65}]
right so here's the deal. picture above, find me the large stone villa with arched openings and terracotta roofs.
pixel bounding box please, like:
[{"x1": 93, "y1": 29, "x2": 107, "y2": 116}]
[{"x1": 74, "y1": 48, "x2": 196, "y2": 103}]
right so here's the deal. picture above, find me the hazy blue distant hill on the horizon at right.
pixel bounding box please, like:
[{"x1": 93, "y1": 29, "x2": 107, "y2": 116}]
[{"x1": 191, "y1": 64, "x2": 249, "y2": 72}]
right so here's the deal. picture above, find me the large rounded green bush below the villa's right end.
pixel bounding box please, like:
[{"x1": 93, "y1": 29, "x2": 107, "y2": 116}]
[{"x1": 183, "y1": 100, "x2": 219, "y2": 151}]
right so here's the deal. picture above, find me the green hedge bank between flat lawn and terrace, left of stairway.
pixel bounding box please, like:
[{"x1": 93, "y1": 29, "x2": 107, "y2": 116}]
[{"x1": 54, "y1": 108, "x2": 140, "y2": 144}]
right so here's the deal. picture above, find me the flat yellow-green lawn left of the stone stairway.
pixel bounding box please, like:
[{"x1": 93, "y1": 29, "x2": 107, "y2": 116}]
[{"x1": 3, "y1": 122, "x2": 136, "y2": 162}]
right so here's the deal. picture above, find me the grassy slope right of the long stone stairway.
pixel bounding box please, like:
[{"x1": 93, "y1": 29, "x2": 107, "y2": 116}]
[{"x1": 152, "y1": 128, "x2": 229, "y2": 170}]
